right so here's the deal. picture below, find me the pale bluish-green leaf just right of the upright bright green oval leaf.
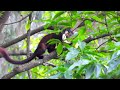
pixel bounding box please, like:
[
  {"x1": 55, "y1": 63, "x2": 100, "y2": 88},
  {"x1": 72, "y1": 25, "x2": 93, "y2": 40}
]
[{"x1": 65, "y1": 48, "x2": 79, "y2": 60}]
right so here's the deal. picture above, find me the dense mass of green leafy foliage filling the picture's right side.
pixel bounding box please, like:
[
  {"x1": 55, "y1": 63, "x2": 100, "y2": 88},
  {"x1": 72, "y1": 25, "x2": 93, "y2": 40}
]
[{"x1": 6, "y1": 11, "x2": 120, "y2": 79}]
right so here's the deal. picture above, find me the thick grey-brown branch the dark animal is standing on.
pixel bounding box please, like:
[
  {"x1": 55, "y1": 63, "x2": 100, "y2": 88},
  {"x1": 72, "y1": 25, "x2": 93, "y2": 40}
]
[{"x1": 1, "y1": 51, "x2": 57, "y2": 79}]
